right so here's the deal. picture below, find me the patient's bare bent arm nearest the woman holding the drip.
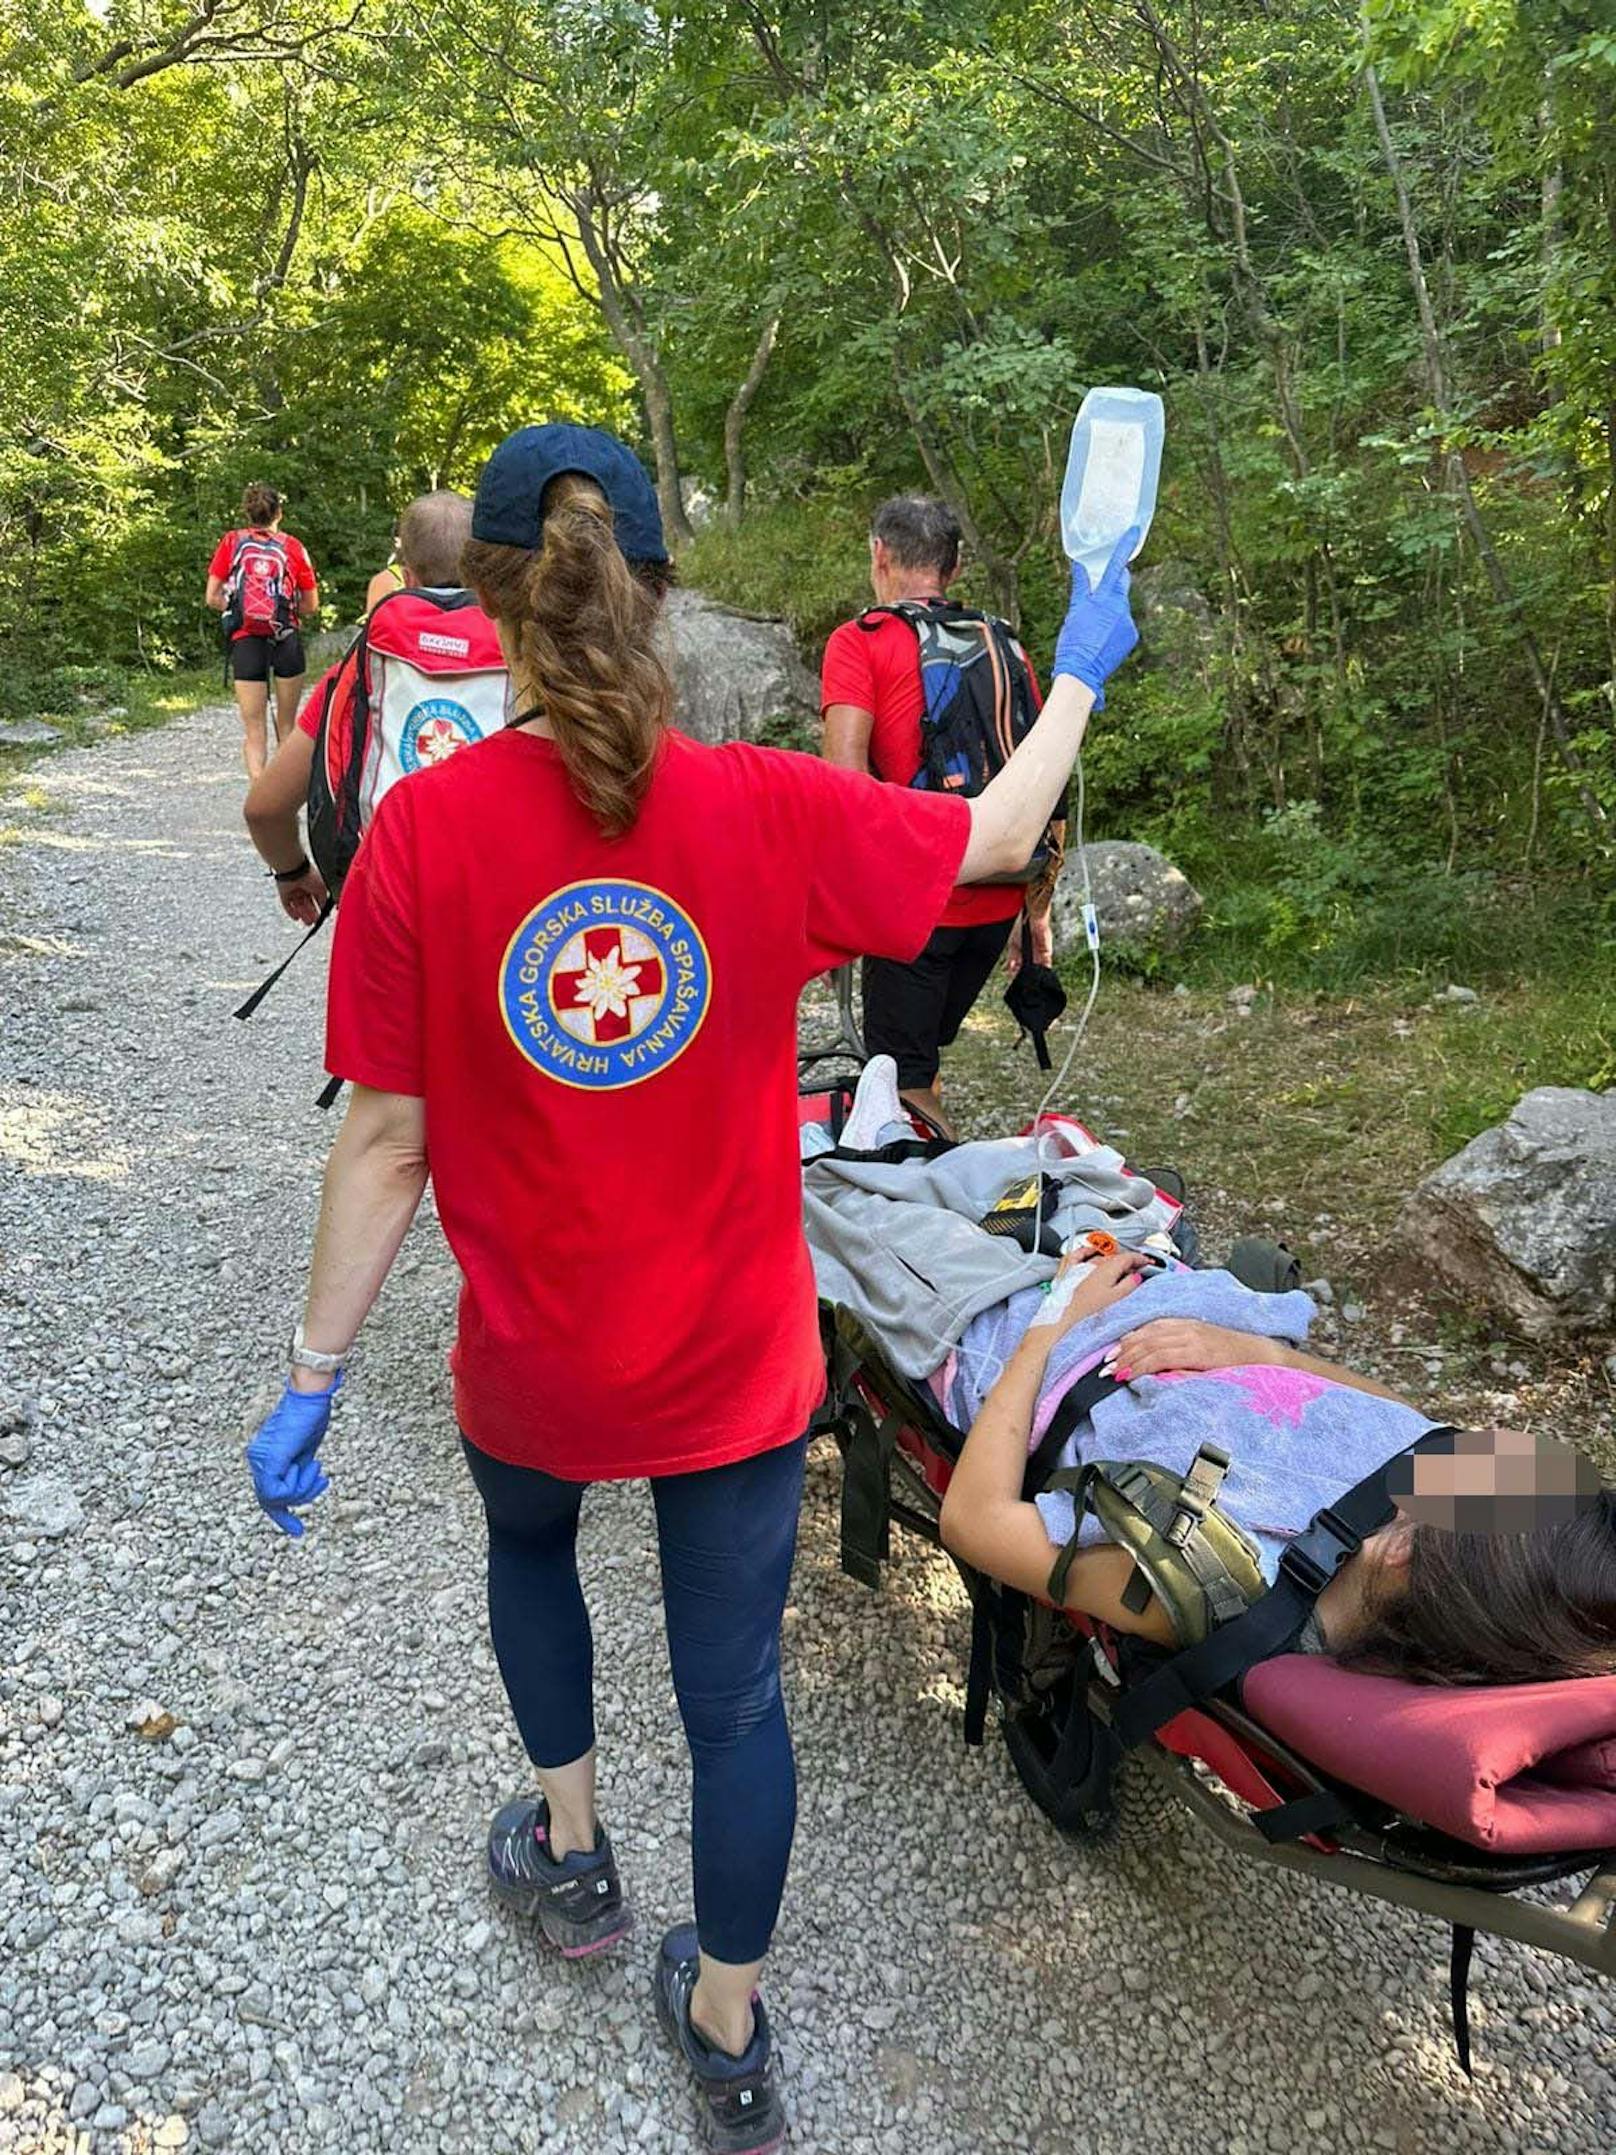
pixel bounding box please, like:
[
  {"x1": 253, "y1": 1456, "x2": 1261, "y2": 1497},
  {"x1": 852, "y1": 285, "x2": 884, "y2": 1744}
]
[{"x1": 942, "y1": 1250, "x2": 1172, "y2": 1644}]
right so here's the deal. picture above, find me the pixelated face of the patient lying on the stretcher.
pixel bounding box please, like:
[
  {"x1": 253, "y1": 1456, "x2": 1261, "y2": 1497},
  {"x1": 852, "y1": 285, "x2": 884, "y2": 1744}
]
[{"x1": 1385, "y1": 1429, "x2": 1601, "y2": 1534}]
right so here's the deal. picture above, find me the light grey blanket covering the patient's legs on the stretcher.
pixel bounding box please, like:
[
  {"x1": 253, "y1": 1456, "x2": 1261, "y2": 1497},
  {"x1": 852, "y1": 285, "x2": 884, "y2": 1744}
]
[{"x1": 802, "y1": 1136, "x2": 1176, "y2": 1377}]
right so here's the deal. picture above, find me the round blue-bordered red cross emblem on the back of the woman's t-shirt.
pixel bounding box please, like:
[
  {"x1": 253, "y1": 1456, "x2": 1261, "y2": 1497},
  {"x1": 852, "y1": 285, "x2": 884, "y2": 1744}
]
[{"x1": 500, "y1": 881, "x2": 713, "y2": 1093}]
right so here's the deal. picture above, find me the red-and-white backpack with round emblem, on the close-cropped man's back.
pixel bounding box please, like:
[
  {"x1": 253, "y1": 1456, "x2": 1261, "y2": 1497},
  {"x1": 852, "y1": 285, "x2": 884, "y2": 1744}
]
[{"x1": 308, "y1": 590, "x2": 509, "y2": 899}]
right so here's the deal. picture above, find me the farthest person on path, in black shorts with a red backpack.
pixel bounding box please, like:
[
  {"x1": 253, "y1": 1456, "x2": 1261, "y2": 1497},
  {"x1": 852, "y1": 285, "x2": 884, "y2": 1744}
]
[{"x1": 207, "y1": 481, "x2": 319, "y2": 778}]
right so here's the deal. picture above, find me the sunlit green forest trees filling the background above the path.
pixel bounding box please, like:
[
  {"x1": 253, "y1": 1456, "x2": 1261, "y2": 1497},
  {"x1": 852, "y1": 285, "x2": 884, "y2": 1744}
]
[{"x1": 0, "y1": 0, "x2": 1616, "y2": 933}]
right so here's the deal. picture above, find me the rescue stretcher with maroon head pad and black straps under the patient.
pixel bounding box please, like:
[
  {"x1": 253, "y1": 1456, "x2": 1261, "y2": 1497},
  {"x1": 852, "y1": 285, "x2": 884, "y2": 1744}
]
[{"x1": 804, "y1": 1069, "x2": 1616, "y2": 2071}]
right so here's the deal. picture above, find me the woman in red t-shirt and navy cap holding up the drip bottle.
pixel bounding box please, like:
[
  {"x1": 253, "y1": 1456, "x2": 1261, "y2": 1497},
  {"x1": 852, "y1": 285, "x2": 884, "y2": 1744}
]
[{"x1": 248, "y1": 427, "x2": 1136, "y2": 2151}]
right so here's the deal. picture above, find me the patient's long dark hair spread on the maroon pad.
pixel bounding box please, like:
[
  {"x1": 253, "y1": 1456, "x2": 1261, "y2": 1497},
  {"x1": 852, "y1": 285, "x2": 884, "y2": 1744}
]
[{"x1": 1340, "y1": 1489, "x2": 1616, "y2": 1683}]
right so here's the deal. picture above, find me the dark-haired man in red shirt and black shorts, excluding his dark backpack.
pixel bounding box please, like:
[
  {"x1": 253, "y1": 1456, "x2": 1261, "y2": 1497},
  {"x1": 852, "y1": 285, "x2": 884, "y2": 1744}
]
[{"x1": 819, "y1": 493, "x2": 1054, "y2": 1136}]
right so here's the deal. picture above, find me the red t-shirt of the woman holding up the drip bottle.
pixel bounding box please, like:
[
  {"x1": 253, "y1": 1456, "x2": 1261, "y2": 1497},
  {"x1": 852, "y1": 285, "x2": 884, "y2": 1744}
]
[{"x1": 325, "y1": 733, "x2": 970, "y2": 1480}]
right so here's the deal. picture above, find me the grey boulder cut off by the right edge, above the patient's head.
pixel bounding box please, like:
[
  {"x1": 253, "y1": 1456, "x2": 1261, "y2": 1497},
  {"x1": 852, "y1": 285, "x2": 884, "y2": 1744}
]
[{"x1": 1403, "y1": 1084, "x2": 1616, "y2": 1340}]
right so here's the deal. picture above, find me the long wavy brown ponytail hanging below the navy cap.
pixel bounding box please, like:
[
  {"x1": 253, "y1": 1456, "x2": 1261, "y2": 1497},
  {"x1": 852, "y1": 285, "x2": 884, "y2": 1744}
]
[{"x1": 461, "y1": 472, "x2": 672, "y2": 838}]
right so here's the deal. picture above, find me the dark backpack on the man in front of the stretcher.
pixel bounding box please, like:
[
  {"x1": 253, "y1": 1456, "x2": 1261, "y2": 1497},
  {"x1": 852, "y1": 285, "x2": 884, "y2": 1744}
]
[{"x1": 858, "y1": 599, "x2": 1060, "y2": 884}]
